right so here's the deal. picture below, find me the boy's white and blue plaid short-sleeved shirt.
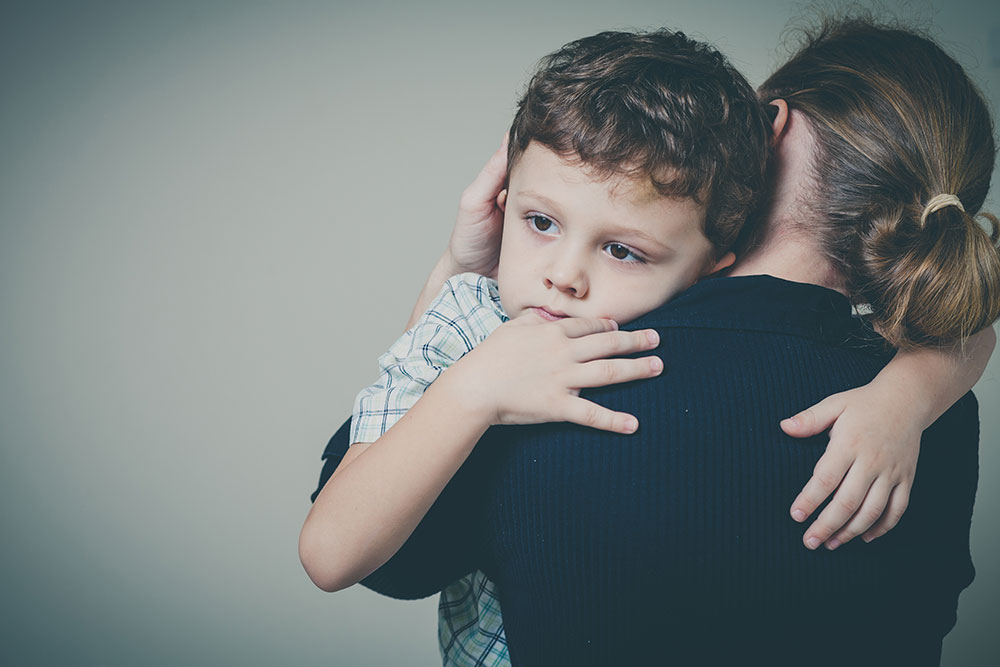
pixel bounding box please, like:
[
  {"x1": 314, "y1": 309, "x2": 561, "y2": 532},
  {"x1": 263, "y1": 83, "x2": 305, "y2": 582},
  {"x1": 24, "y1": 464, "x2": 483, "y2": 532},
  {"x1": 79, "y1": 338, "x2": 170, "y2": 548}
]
[{"x1": 351, "y1": 273, "x2": 510, "y2": 667}]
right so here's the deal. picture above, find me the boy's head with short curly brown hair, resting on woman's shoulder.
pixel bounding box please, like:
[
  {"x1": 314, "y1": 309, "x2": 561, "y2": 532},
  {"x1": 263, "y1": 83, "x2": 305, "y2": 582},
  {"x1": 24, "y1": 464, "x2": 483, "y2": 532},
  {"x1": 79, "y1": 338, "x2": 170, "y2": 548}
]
[{"x1": 498, "y1": 30, "x2": 770, "y2": 321}]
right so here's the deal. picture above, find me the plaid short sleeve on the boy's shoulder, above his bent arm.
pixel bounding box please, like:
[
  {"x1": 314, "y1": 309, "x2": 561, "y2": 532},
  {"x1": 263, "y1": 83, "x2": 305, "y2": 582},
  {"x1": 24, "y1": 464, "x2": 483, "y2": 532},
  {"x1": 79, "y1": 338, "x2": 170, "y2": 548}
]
[{"x1": 350, "y1": 274, "x2": 505, "y2": 443}]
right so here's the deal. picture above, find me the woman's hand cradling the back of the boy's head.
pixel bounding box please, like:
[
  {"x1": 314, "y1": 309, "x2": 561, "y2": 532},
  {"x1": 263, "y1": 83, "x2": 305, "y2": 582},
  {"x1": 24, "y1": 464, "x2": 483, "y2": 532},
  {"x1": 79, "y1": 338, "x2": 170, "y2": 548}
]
[{"x1": 448, "y1": 134, "x2": 507, "y2": 278}]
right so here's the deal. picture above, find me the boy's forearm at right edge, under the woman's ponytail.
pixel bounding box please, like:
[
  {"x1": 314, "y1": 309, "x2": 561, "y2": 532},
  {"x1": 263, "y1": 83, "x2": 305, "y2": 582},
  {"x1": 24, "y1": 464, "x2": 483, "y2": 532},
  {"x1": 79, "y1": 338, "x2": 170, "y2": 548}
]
[{"x1": 873, "y1": 327, "x2": 996, "y2": 428}]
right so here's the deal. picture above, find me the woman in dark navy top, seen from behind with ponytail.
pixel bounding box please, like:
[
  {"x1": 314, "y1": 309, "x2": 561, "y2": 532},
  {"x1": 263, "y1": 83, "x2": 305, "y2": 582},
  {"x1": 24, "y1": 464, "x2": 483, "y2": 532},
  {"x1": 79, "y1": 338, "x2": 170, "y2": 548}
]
[{"x1": 308, "y1": 15, "x2": 1000, "y2": 664}]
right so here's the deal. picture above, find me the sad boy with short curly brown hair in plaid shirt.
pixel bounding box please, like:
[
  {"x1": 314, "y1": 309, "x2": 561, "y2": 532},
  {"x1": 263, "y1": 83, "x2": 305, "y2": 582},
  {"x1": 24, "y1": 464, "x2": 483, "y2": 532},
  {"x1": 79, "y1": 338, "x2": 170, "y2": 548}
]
[{"x1": 304, "y1": 30, "x2": 769, "y2": 664}]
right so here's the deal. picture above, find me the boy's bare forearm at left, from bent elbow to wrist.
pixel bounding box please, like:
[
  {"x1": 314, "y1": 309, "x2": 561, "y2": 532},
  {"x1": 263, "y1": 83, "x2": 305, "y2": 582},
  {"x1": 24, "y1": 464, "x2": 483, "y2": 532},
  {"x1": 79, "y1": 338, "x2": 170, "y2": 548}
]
[{"x1": 299, "y1": 373, "x2": 490, "y2": 591}]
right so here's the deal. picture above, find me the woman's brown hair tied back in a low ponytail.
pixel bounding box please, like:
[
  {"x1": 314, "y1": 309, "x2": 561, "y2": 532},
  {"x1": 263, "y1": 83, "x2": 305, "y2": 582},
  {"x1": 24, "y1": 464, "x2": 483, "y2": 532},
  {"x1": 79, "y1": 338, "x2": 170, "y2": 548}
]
[{"x1": 758, "y1": 19, "x2": 1000, "y2": 347}]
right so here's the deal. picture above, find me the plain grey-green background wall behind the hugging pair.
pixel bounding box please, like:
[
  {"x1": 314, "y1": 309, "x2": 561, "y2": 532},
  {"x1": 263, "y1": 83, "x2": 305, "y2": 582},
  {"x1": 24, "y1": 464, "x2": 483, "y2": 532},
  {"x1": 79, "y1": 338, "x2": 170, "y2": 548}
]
[{"x1": 0, "y1": 0, "x2": 1000, "y2": 665}]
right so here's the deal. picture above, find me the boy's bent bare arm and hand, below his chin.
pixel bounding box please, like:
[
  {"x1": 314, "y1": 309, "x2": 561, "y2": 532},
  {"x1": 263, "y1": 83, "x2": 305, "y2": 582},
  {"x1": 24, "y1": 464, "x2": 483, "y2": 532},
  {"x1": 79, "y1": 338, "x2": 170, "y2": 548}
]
[{"x1": 299, "y1": 316, "x2": 662, "y2": 591}]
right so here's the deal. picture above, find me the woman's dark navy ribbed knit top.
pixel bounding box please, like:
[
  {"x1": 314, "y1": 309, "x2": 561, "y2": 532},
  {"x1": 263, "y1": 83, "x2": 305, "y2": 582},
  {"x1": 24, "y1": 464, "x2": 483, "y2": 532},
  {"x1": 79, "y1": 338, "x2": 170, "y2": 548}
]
[{"x1": 320, "y1": 276, "x2": 978, "y2": 666}]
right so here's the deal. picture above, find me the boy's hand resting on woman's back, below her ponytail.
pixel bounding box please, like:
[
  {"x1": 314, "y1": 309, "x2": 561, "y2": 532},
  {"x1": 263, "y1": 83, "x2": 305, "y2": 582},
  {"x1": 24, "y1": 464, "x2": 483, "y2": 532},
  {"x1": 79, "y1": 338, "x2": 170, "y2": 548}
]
[{"x1": 781, "y1": 382, "x2": 922, "y2": 549}]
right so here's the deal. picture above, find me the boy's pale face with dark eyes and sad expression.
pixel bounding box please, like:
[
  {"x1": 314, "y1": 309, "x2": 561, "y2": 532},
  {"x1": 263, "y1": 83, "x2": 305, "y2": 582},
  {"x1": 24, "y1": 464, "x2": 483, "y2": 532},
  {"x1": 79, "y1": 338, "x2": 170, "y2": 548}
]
[{"x1": 497, "y1": 142, "x2": 732, "y2": 323}]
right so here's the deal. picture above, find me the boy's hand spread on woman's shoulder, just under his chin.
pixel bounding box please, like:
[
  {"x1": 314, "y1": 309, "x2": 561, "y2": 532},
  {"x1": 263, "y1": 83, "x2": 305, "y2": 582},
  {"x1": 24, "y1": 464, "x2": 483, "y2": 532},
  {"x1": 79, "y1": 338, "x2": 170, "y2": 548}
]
[{"x1": 450, "y1": 314, "x2": 663, "y2": 433}]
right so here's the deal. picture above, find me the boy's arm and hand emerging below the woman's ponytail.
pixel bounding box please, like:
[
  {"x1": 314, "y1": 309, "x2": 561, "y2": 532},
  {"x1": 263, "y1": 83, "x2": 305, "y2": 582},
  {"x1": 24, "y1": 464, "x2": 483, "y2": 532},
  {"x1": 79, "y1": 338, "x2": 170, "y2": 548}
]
[{"x1": 781, "y1": 327, "x2": 996, "y2": 549}]
